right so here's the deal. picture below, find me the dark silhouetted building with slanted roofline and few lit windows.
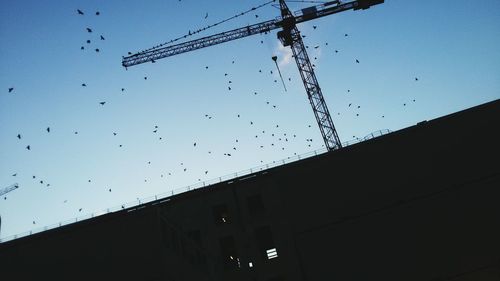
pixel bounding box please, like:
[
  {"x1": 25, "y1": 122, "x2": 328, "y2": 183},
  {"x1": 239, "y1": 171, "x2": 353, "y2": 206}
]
[{"x1": 0, "y1": 100, "x2": 500, "y2": 281}]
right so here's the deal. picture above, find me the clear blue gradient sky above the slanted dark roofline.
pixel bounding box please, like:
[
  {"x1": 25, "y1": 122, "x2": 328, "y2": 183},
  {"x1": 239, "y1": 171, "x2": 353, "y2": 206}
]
[{"x1": 0, "y1": 0, "x2": 500, "y2": 237}]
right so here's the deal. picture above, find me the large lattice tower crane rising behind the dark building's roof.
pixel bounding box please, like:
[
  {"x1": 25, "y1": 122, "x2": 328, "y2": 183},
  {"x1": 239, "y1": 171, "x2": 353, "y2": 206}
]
[{"x1": 122, "y1": 0, "x2": 384, "y2": 151}]
